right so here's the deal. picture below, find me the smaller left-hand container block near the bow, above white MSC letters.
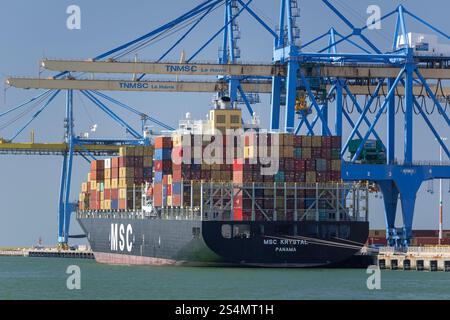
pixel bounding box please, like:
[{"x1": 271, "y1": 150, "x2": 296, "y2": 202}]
[{"x1": 79, "y1": 146, "x2": 153, "y2": 211}]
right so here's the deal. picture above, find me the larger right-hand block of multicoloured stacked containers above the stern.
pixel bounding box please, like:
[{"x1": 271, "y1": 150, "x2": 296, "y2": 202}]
[{"x1": 149, "y1": 133, "x2": 341, "y2": 220}]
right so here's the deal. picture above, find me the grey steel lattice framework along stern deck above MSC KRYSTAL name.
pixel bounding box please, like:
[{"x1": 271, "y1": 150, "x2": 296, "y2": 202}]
[{"x1": 183, "y1": 182, "x2": 369, "y2": 221}]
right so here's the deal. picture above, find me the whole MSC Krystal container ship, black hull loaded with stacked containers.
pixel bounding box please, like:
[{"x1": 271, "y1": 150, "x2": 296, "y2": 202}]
[{"x1": 77, "y1": 98, "x2": 369, "y2": 268}]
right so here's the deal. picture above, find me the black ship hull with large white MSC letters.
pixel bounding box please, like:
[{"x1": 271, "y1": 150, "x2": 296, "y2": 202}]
[{"x1": 78, "y1": 217, "x2": 369, "y2": 268}]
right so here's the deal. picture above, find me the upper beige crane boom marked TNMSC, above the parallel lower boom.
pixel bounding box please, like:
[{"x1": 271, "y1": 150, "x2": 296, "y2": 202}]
[{"x1": 42, "y1": 60, "x2": 450, "y2": 79}]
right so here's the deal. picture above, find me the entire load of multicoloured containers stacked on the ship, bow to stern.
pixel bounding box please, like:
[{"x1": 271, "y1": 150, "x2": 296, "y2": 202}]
[{"x1": 80, "y1": 133, "x2": 341, "y2": 220}]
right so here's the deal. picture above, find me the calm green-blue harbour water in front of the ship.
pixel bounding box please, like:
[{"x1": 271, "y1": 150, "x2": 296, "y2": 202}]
[{"x1": 0, "y1": 257, "x2": 450, "y2": 300}]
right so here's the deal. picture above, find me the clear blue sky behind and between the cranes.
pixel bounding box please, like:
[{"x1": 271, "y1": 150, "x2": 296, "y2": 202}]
[{"x1": 0, "y1": 0, "x2": 450, "y2": 246}]
